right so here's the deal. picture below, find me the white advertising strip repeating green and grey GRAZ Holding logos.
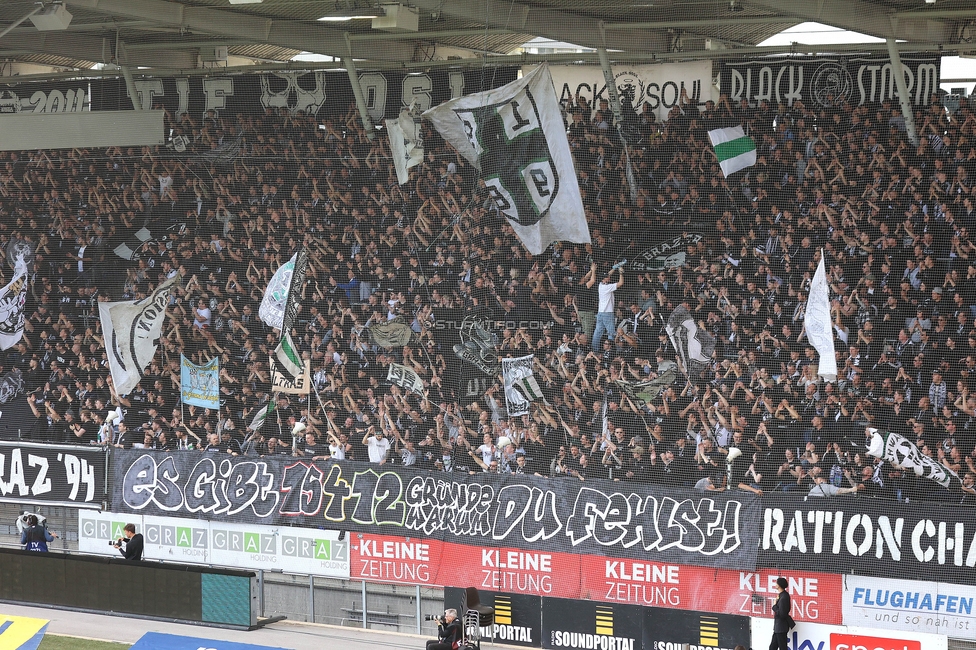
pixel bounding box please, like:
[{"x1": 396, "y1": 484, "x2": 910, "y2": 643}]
[{"x1": 78, "y1": 512, "x2": 349, "y2": 579}]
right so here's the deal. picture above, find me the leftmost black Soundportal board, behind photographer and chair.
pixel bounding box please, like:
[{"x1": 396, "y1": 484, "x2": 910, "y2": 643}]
[{"x1": 444, "y1": 587, "x2": 542, "y2": 648}]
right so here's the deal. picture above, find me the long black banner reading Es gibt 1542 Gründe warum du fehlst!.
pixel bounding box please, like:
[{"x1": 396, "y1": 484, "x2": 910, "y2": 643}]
[{"x1": 112, "y1": 450, "x2": 760, "y2": 571}]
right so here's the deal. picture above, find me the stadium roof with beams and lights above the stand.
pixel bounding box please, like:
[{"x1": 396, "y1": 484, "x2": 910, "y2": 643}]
[{"x1": 0, "y1": 0, "x2": 976, "y2": 74}]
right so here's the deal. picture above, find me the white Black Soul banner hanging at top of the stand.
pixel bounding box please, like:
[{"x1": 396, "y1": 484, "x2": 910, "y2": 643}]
[{"x1": 524, "y1": 61, "x2": 712, "y2": 121}]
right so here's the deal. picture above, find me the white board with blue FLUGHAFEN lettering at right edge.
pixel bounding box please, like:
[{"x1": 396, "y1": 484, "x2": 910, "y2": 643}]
[{"x1": 844, "y1": 576, "x2": 976, "y2": 640}]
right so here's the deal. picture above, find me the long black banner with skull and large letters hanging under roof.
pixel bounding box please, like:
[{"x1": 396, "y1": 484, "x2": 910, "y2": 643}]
[{"x1": 91, "y1": 68, "x2": 518, "y2": 120}]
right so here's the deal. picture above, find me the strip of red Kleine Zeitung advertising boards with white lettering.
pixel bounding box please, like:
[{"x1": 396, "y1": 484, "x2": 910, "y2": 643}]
[{"x1": 350, "y1": 534, "x2": 843, "y2": 625}]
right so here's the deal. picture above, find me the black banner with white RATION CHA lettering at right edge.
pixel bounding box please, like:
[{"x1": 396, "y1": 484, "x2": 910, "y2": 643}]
[{"x1": 759, "y1": 495, "x2": 976, "y2": 584}]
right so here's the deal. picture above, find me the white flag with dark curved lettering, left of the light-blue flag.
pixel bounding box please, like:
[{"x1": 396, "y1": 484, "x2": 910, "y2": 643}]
[{"x1": 98, "y1": 275, "x2": 180, "y2": 395}]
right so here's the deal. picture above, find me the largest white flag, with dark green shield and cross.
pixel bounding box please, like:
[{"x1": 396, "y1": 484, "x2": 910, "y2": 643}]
[{"x1": 424, "y1": 65, "x2": 590, "y2": 255}]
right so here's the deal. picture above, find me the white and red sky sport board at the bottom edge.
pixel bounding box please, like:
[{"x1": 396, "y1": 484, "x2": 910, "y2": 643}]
[{"x1": 752, "y1": 618, "x2": 948, "y2": 650}]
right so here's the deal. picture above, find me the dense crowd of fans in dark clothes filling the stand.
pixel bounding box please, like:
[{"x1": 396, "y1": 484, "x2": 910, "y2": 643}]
[{"x1": 0, "y1": 79, "x2": 976, "y2": 502}]
